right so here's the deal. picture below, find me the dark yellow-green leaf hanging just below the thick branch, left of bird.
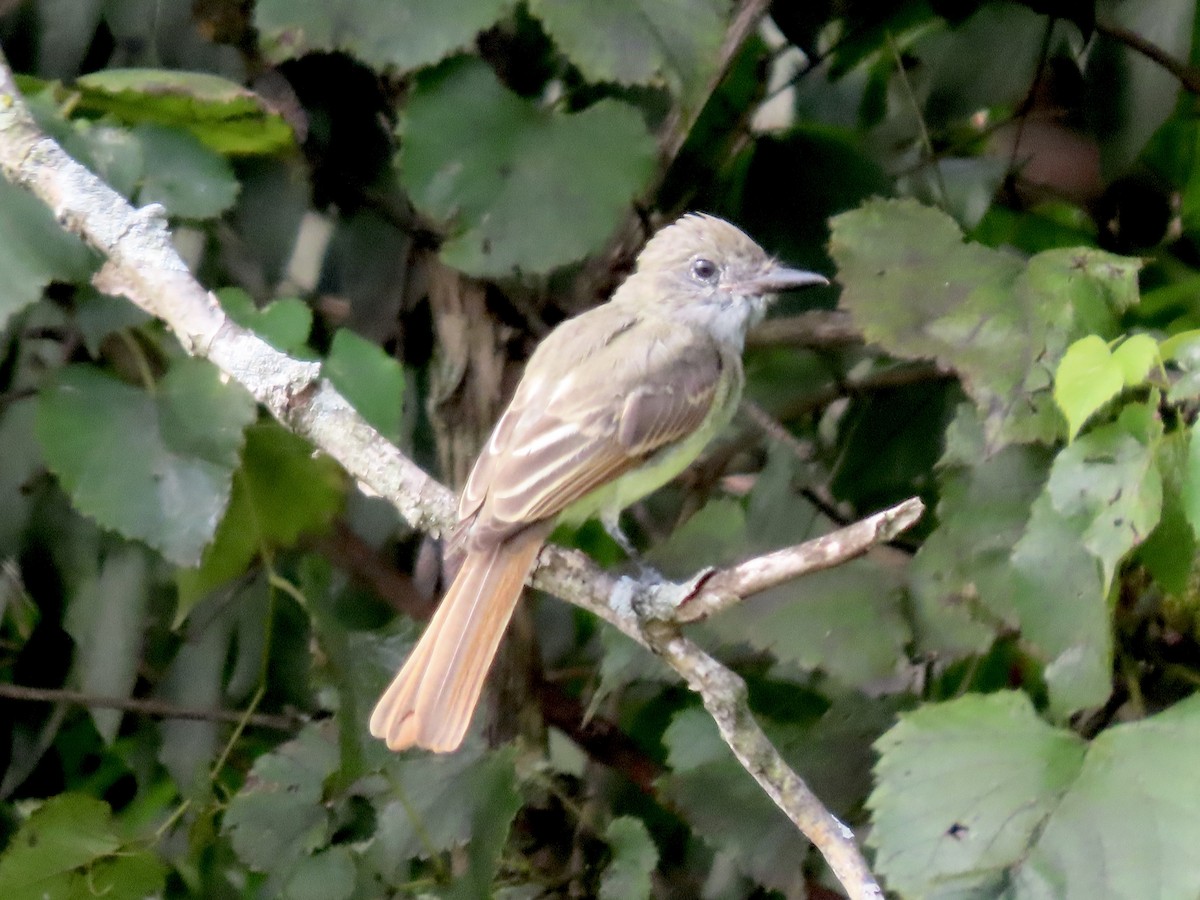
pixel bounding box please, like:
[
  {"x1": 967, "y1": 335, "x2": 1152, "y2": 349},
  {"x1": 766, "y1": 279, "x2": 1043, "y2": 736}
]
[{"x1": 175, "y1": 422, "x2": 344, "y2": 625}]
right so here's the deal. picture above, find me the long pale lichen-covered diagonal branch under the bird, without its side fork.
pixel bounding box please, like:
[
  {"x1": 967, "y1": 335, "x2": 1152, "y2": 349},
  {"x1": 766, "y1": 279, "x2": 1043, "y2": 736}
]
[{"x1": 0, "y1": 56, "x2": 882, "y2": 899}]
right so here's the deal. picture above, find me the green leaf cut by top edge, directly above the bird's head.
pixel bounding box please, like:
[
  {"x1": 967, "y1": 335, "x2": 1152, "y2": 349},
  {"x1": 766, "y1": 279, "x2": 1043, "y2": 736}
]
[{"x1": 529, "y1": 0, "x2": 730, "y2": 109}]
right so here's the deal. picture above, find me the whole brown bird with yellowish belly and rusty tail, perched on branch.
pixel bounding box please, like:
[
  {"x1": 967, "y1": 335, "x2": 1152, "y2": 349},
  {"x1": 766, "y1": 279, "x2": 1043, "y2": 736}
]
[{"x1": 371, "y1": 214, "x2": 827, "y2": 752}]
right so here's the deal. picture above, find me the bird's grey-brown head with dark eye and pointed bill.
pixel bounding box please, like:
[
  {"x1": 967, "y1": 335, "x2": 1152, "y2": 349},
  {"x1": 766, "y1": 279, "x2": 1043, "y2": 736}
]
[{"x1": 626, "y1": 212, "x2": 829, "y2": 336}]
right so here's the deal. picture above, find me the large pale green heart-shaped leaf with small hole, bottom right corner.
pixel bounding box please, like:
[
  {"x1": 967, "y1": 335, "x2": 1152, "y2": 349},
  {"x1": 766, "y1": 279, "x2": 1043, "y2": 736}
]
[{"x1": 870, "y1": 694, "x2": 1200, "y2": 898}]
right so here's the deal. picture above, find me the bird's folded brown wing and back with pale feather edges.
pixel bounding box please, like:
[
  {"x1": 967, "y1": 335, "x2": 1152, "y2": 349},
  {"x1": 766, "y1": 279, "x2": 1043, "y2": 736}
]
[{"x1": 460, "y1": 318, "x2": 726, "y2": 544}]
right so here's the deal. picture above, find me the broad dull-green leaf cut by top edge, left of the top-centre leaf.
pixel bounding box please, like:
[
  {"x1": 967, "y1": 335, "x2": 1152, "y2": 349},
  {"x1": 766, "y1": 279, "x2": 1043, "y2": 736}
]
[{"x1": 254, "y1": 0, "x2": 514, "y2": 72}]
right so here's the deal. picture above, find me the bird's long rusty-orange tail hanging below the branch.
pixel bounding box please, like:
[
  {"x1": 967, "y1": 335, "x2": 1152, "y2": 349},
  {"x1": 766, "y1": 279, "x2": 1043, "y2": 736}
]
[{"x1": 371, "y1": 526, "x2": 546, "y2": 752}]
